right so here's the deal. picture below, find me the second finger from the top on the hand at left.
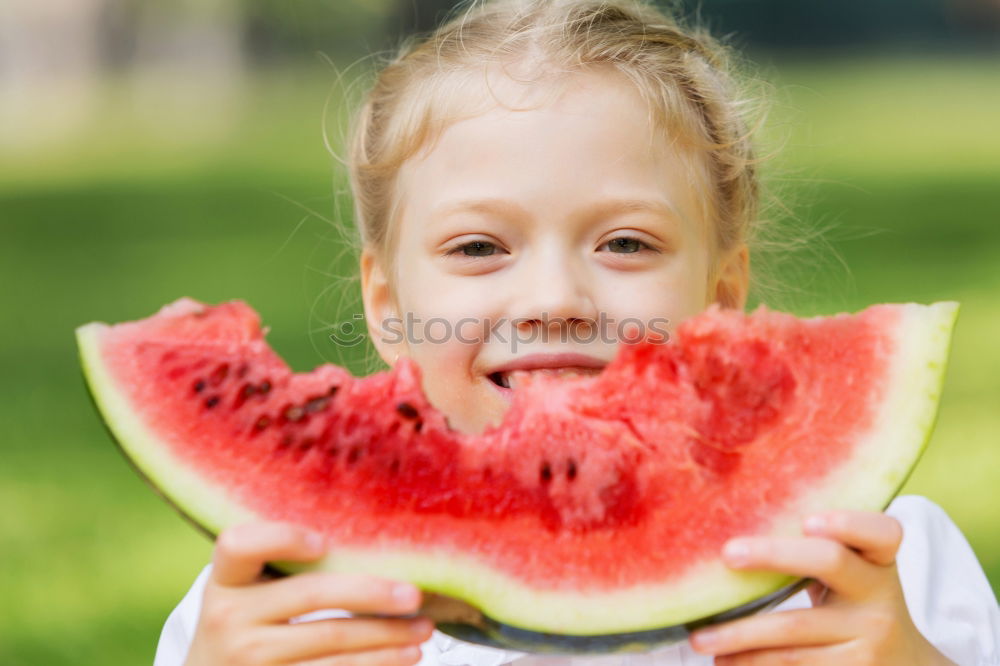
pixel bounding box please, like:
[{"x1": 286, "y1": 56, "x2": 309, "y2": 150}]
[{"x1": 248, "y1": 571, "x2": 421, "y2": 622}]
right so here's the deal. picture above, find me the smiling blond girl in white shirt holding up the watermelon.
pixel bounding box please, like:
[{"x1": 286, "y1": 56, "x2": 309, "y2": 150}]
[{"x1": 156, "y1": 0, "x2": 1000, "y2": 666}]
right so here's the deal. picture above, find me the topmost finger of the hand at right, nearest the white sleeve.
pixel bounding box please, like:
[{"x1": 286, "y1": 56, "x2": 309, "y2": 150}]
[{"x1": 803, "y1": 511, "x2": 903, "y2": 566}]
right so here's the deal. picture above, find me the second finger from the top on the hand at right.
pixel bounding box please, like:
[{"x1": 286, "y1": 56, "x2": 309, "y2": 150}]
[{"x1": 722, "y1": 537, "x2": 882, "y2": 599}]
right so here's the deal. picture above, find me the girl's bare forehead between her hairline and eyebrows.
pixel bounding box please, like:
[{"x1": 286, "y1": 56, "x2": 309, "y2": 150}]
[{"x1": 397, "y1": 66, "x2": 708, "y2": 228}]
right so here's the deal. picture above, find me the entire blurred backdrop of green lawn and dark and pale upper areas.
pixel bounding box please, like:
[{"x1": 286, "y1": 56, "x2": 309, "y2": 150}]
[{"x1": 0, "y1": 0, "x2": 1000, "y2": 665}]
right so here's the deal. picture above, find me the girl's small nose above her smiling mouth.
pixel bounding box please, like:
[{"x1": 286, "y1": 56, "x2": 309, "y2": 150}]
[{"x1": 511, "y1": 245, "x2": 598, "y2": 330}]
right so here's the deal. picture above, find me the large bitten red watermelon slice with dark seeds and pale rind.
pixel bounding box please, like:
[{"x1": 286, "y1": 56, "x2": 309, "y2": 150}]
[{"x1": 77, "y1": 299, "x2": 958, "y2": 652}]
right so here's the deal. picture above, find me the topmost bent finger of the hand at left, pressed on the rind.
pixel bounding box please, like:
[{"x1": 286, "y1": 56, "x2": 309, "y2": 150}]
[{"x1": 212, "y1": 523, "x2": 325, "y2": 586}]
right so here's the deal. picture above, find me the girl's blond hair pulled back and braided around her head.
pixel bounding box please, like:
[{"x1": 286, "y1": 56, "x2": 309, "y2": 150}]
[{"x1": 347, "y1": 0, "x2": 759, "y2": 278}]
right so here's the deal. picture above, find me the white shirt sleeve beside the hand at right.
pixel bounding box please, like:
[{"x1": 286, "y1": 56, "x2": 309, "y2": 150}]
[{"x1": 886, "y1": 495, "x2": 1000, "y2": 666}]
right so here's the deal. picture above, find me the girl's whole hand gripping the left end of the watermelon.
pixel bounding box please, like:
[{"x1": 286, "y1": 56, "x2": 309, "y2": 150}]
[{"x1": 186, "y1": 523, "x2": 434, "y2": 666}]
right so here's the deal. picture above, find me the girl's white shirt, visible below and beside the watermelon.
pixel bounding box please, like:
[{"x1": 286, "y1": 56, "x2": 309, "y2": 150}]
[{"x1": 154, "y1": 495, "x2": 1000, "y2": 666}]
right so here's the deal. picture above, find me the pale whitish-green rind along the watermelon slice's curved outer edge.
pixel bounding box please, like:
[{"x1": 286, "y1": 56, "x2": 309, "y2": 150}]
[{"x1": 78, "y1": 302, "x2": 958, "y2": 635}]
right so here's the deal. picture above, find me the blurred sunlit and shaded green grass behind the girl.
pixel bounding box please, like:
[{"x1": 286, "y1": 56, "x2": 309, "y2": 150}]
[{"x1": 0, "y1": 58, "x2": 1000, "y2": 665}]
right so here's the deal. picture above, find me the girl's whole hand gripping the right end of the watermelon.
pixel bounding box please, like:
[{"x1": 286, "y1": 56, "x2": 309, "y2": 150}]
[{"x1": 691, "y1": 511, "x2": 954, "y2": 666}]
